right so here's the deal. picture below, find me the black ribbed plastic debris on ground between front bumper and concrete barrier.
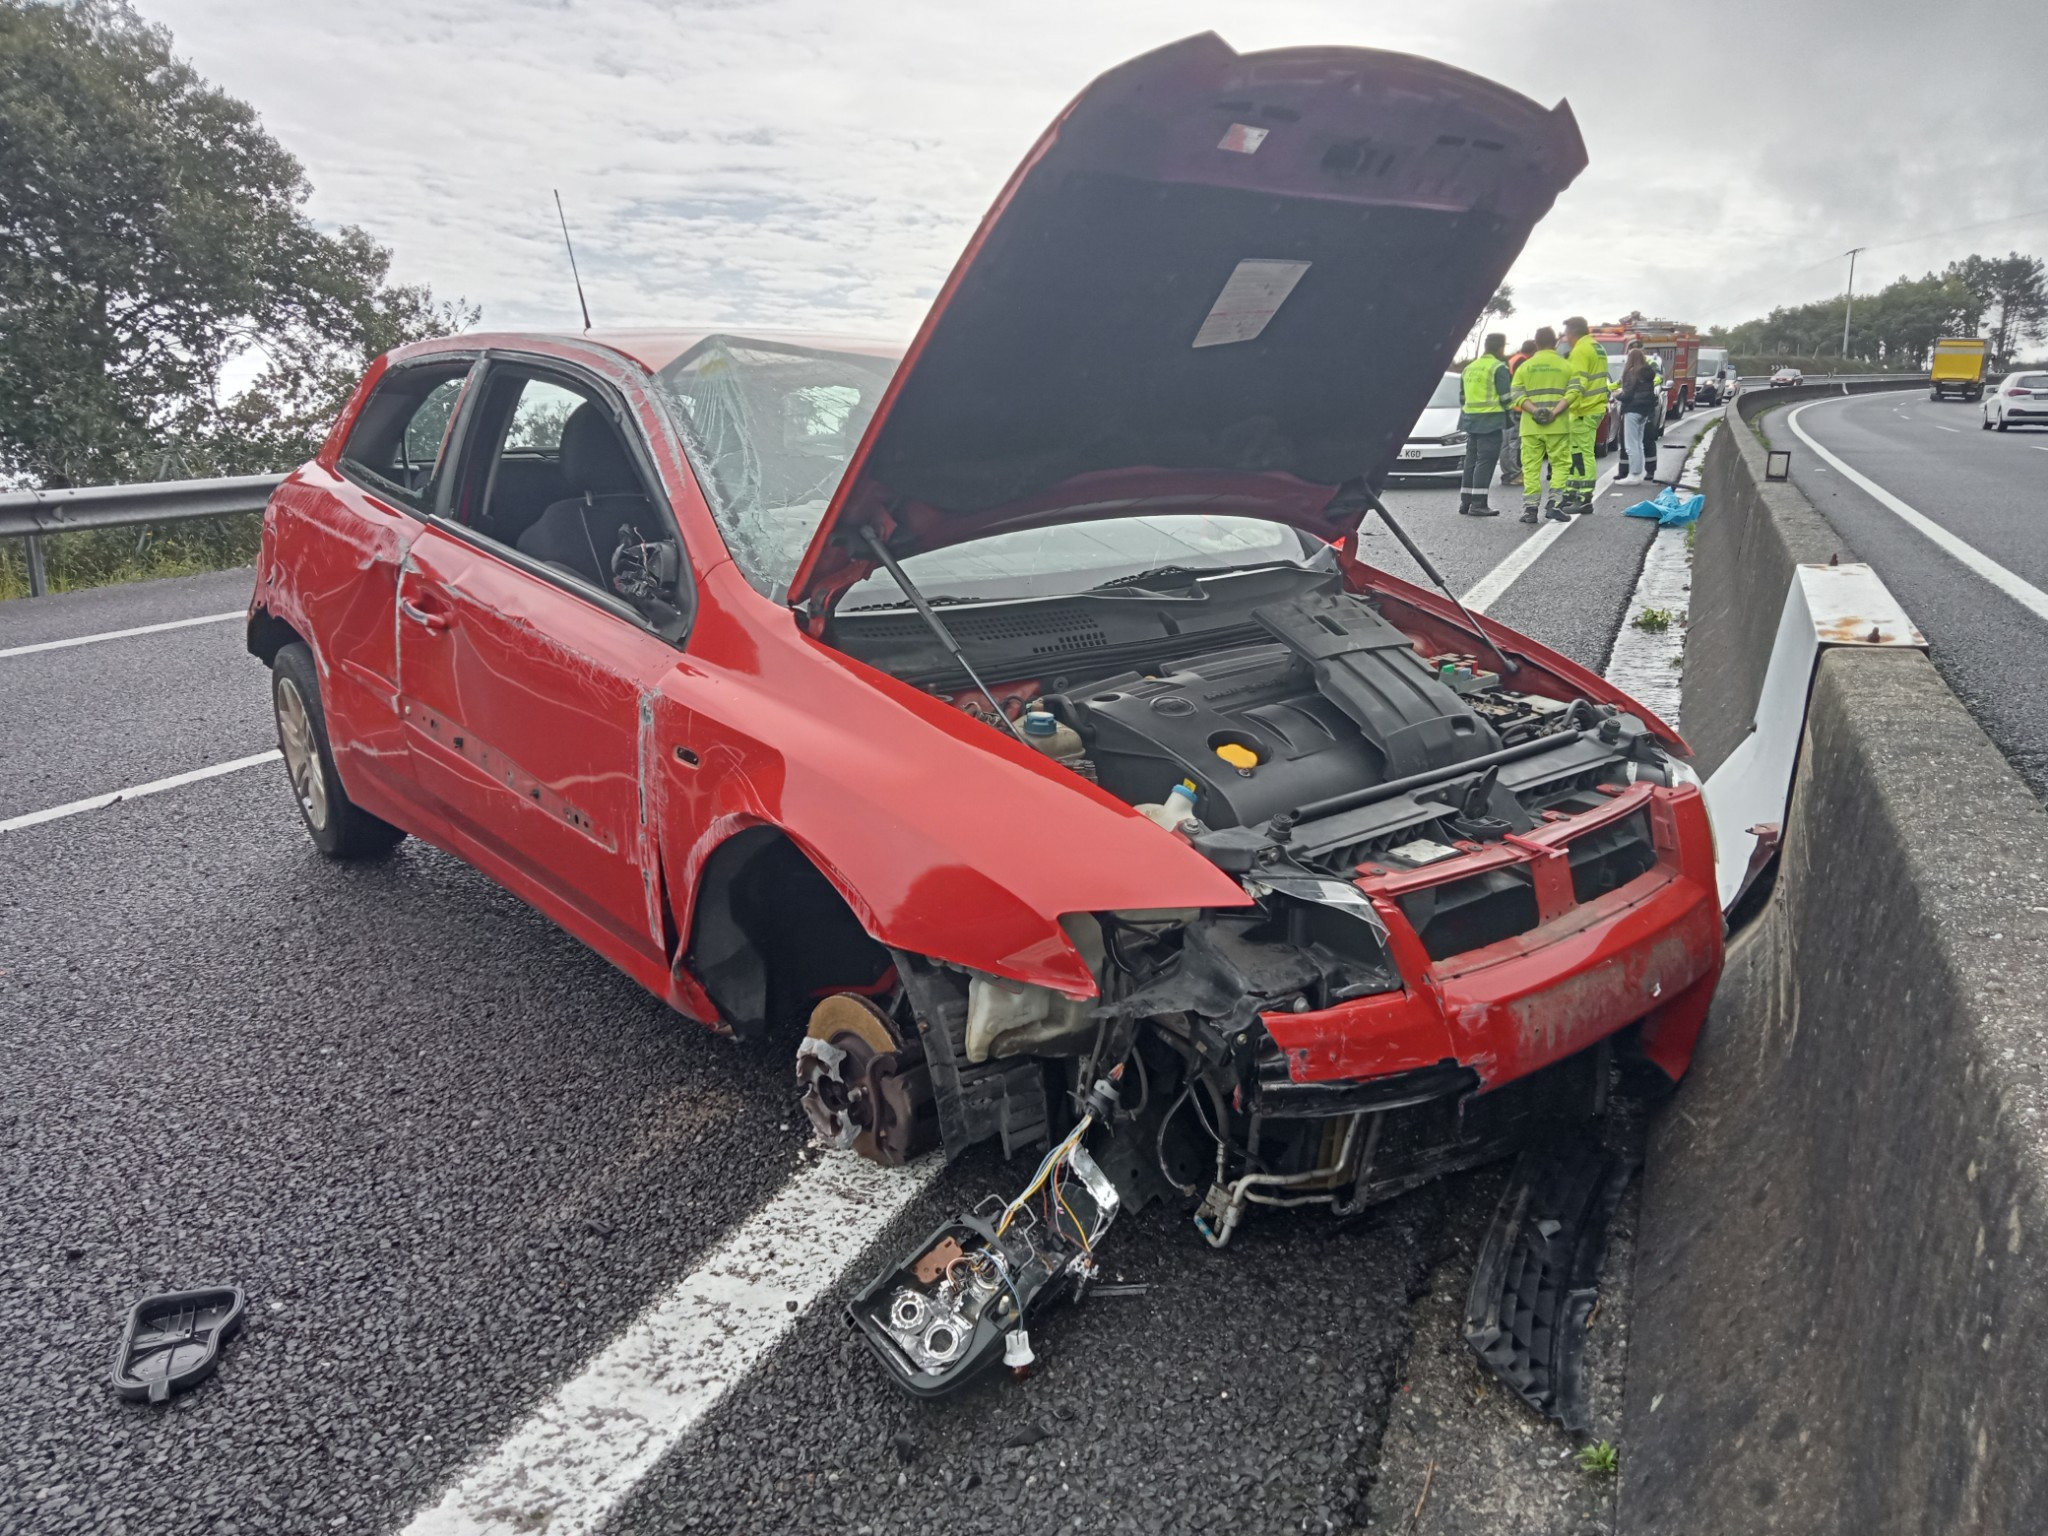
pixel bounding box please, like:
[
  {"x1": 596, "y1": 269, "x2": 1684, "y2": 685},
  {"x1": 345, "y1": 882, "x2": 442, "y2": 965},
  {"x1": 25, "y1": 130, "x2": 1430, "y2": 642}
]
[{"x1": 1464, "y1": 1141, "x2": 1634, "y2": 1430}]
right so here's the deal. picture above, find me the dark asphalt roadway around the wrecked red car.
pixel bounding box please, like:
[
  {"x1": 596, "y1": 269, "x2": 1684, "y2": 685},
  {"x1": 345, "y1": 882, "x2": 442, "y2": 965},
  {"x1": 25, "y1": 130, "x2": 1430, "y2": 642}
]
[{"x1": 0, "y1": 428, "x2": 1712, "y2": 1536}]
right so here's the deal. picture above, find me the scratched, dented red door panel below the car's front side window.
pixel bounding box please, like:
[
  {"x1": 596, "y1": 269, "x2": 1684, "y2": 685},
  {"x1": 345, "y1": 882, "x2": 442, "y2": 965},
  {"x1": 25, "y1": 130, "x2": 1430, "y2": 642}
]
[{"x1": 397, "y1": 518, "x2": 676, "y2": 977}]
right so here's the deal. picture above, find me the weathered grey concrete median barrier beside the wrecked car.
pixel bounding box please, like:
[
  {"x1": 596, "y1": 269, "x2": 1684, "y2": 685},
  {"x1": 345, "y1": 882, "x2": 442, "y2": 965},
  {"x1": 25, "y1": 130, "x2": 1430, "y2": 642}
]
[{"x1": 1620, "y1": 383, "x2": 2048, "y2": 1536}]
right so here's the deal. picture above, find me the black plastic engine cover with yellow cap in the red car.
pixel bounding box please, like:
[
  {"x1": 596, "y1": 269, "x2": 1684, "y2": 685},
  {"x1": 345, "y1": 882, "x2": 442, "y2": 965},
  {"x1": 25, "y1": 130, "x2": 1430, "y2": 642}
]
[{"x1": 1071, "y1": 596, "x2": 1499, "y2": 827}]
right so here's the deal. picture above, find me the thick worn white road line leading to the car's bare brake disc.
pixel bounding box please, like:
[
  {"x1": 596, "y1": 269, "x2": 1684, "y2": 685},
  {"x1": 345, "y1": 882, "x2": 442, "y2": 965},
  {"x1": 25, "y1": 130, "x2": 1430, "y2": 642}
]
[{"x1": 401, "y1": 1153, "x2": 942, "y2": 1536}]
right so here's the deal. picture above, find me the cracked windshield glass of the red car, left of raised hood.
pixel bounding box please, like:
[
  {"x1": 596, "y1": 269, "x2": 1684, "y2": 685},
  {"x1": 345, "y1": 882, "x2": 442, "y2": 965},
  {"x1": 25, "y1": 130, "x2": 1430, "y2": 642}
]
[{"x1": 655, "y1": 336, "x2": 897, "y2": 598}]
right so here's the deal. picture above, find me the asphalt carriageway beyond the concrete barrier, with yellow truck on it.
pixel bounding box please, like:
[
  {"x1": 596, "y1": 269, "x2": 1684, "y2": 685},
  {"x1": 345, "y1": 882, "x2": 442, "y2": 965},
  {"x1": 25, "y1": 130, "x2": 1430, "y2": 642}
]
[{"x1": 1761, "y1": 389, "x2": 2048, "y2": 799}]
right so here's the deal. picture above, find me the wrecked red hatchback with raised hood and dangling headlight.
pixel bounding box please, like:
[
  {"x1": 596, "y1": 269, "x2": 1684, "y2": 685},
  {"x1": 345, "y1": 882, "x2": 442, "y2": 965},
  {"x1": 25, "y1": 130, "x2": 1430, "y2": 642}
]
[{"x1": 250, "y1": 37, "x2": 1722, "y2": 1391}]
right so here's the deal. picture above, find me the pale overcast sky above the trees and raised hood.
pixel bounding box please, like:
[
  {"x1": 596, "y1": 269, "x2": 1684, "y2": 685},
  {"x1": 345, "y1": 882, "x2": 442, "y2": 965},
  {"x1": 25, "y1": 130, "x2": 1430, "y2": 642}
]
[{"x1": 137, "y1": 0, "x2": 2048, "y2": 336}]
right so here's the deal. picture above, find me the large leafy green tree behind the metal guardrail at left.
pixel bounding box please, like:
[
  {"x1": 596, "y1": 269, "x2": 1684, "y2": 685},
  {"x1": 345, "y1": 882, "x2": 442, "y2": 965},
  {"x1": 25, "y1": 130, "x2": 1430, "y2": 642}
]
[{"x1": 0, "y1": 0, "x2": 477, "y2": 485}]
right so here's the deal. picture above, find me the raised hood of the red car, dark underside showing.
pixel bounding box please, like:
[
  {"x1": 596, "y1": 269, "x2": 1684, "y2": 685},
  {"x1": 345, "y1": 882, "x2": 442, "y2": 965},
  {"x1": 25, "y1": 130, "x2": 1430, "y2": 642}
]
[{"x1": 788, "y1": 33, "x2": 1585, "y2": 606}]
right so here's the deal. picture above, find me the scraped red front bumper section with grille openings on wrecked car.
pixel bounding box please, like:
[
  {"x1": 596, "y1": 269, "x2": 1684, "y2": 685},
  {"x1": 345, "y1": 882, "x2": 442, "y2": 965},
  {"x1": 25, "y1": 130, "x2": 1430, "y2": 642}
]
[{"x1": 1264, "y1": 784, "x2": 1722, "y2": 1092}]
